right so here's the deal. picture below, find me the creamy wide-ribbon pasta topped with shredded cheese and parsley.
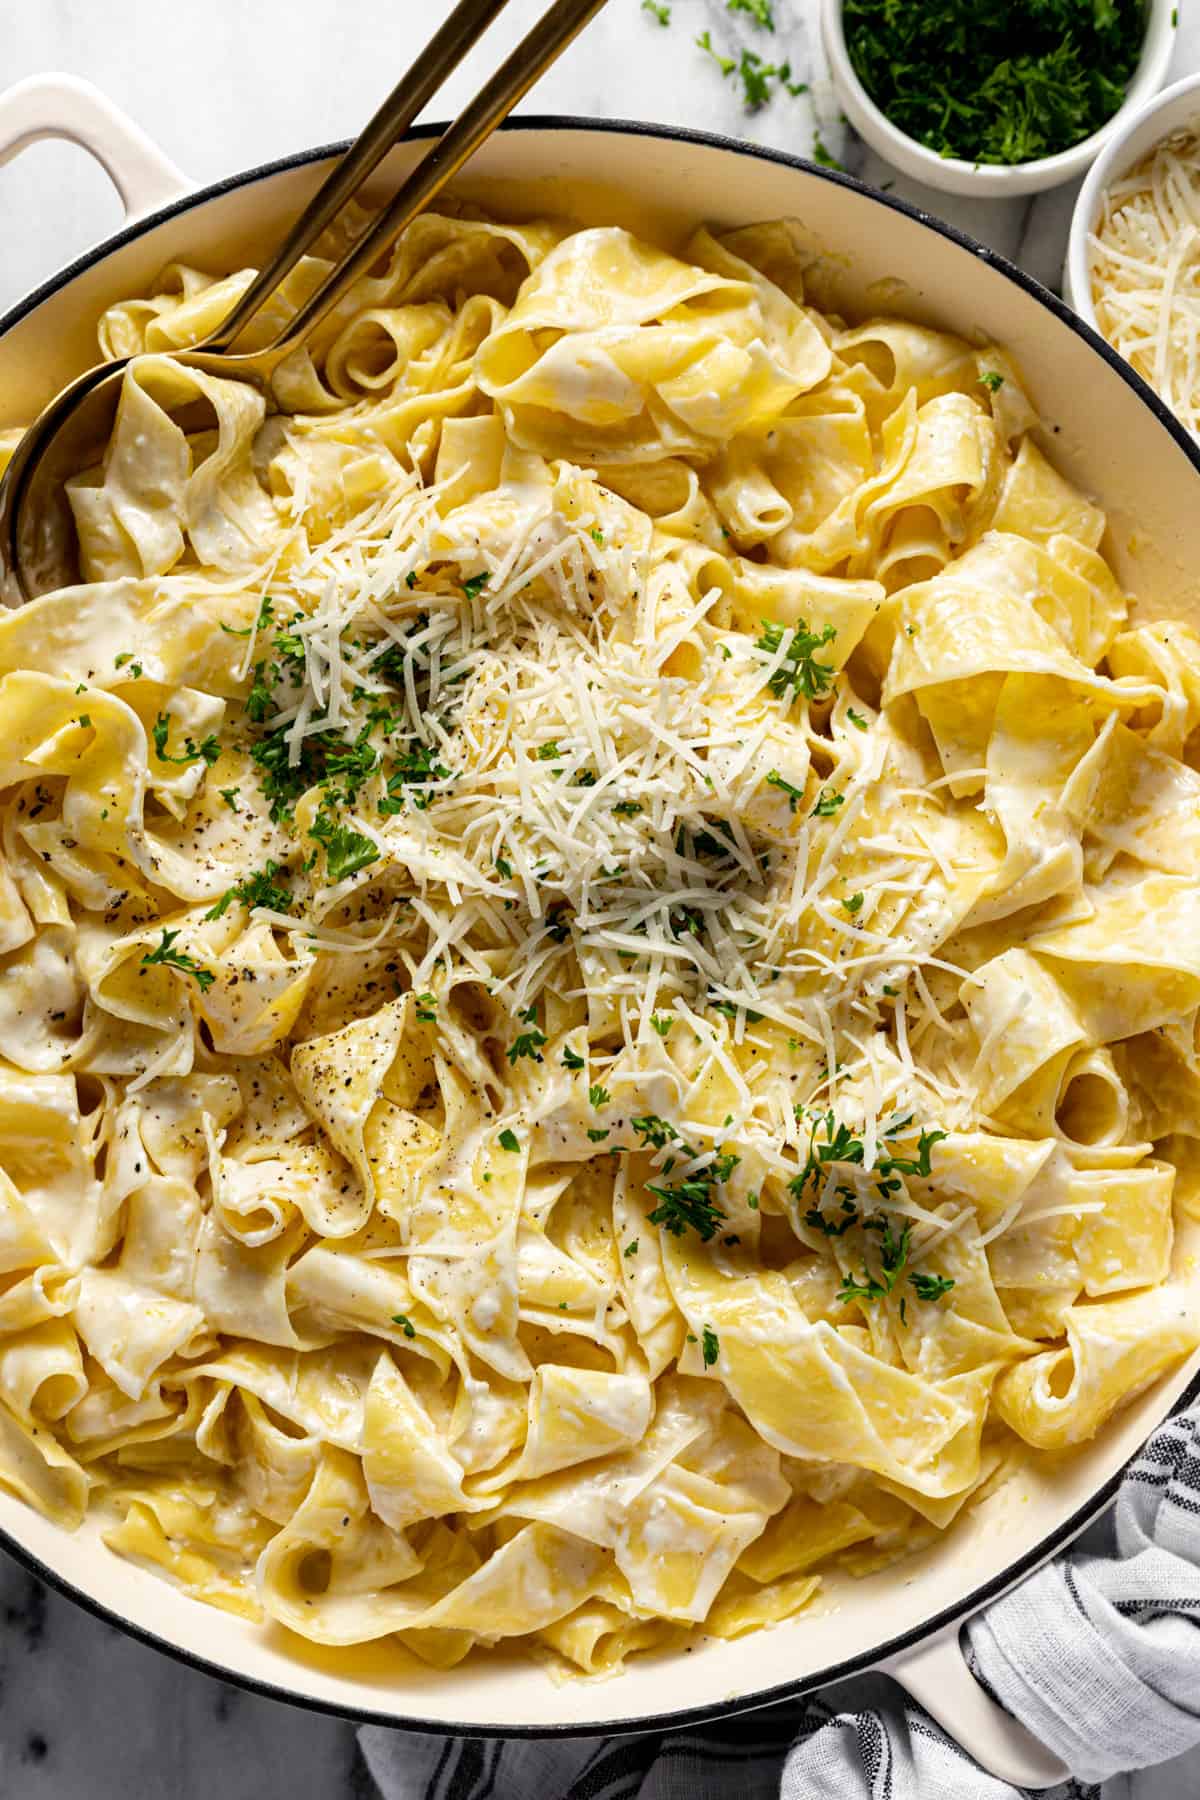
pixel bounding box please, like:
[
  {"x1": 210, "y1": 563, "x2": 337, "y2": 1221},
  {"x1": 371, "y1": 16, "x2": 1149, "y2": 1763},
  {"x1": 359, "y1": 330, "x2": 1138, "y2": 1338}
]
[{"x1": 0, "y1": 211, "x2": 1200, "y2": 1674}]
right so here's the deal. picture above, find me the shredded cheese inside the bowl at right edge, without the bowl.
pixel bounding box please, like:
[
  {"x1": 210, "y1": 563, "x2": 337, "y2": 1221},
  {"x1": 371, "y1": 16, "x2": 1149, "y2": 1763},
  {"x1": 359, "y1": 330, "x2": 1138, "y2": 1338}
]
[{"x1": 1088, "y1": 131, "x2": 1200, "y2": 436}]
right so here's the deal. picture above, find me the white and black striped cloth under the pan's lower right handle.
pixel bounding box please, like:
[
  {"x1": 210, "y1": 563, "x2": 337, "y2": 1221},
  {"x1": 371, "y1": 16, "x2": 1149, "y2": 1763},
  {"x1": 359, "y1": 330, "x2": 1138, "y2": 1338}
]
[{"x1": 360, "y1": 1408, "x2": 1200, "y2": 1800}]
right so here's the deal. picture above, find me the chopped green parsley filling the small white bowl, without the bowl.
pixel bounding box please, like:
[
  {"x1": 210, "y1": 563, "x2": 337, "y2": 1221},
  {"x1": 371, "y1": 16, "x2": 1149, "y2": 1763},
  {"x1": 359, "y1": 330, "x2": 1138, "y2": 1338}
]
[{"x1": 842, "y1": 0, "x2": 1146, "y2": 166}]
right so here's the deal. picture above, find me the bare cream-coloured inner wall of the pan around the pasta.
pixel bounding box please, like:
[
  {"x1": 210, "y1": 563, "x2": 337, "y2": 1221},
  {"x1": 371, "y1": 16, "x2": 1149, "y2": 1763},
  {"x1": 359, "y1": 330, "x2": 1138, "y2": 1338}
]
[{"x1": 0, "y1": 128, "x2": 1200, "y2": 1730}]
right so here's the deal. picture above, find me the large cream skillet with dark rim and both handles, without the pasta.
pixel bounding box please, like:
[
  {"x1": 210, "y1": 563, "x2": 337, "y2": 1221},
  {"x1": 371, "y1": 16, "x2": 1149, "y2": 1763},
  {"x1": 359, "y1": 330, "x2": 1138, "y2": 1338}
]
[{"x1": 0, "y1": 76, "x2": 1200, "y2": 1787}]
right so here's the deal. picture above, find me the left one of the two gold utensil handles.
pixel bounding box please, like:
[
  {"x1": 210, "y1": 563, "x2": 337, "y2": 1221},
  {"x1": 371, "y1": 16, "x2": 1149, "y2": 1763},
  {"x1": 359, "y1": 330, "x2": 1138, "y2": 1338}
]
[{"x1": 206, "y1": 0, "x2": 507, "y2": 351}]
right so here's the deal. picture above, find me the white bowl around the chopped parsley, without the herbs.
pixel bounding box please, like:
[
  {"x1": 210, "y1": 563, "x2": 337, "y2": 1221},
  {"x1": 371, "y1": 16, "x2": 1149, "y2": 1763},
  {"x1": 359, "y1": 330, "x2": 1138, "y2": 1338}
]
[{"x1": 820, "y1": 0, "x2": 1178, "y2": 200}]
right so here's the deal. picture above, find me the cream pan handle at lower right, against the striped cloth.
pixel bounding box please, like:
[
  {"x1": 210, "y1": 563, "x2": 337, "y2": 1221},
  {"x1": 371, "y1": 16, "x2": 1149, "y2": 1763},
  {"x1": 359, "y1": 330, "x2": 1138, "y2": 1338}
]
[{"x1": 880, "y1": 1625, "x2": 1070, "y2": 1787}]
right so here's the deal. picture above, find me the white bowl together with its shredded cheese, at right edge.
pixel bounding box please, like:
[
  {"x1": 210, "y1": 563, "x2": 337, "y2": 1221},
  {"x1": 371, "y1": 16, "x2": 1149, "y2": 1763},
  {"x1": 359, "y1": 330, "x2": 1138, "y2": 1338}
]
[{"x1": 1063, "y1": 76, "x2": 1200, "y2": 434}]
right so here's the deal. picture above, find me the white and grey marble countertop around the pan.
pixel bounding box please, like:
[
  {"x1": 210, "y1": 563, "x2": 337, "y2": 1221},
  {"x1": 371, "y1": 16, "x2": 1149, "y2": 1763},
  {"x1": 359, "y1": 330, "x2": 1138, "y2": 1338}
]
[{"x1": 0, "y1": 0, "x2": 1200, "y2": 1800}]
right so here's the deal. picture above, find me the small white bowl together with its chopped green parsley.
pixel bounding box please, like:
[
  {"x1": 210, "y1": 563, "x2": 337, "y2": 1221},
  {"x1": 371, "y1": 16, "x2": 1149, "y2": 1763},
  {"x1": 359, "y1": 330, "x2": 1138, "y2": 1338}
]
[{"x1": 822, "y1": 0, "x2": 1178, "y2": 196}]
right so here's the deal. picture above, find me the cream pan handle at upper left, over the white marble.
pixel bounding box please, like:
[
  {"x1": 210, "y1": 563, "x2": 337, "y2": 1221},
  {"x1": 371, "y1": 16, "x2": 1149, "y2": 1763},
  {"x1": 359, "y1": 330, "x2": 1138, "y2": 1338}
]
[{"x1": 0, "y1": 72, "x2": 193, "y2": 220}]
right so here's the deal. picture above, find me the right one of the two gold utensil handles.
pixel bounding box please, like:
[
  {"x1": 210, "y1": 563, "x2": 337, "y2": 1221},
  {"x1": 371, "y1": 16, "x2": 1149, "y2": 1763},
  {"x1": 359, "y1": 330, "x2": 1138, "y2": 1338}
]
[{"x1": 272, "y1": 0, "x2": 604, "y2": 349}]
